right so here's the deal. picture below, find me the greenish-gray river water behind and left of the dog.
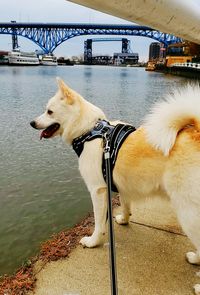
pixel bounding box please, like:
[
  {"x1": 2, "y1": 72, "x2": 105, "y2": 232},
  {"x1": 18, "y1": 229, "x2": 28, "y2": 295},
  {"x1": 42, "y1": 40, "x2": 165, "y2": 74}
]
[{"x1": 0, "y1": 66, "x2": 190, "y2": 274}]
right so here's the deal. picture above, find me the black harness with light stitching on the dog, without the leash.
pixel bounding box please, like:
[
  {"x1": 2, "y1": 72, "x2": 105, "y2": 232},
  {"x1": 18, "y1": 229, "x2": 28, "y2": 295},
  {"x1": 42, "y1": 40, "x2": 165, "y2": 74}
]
[{"x1": 72, "y1": 120, "x2": 136, "y2": 192}]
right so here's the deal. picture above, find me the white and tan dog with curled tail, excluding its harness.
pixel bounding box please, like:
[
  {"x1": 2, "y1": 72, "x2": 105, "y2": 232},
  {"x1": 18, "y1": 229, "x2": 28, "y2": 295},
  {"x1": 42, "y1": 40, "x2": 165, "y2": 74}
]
[{"x1": 31, "y1": 79, "x2": 200, "y2": 294}]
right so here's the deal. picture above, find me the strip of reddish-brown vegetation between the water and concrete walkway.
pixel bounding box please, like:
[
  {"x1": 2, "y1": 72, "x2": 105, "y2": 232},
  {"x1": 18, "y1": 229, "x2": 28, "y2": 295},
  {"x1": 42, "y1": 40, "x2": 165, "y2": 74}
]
[{"x1": 0, "y1": 213, "x2": 94, "y2": 295}]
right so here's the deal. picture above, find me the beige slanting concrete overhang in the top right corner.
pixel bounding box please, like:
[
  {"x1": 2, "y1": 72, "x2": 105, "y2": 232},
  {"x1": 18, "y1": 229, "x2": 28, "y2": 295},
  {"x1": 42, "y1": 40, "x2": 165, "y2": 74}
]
[{"x1": 67, "y1": 0, "x2": 200, "y2": 44}]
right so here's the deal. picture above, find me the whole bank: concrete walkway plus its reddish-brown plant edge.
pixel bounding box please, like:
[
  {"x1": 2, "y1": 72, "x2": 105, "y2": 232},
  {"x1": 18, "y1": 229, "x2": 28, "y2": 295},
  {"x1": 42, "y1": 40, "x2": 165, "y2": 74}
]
[{"x1": 0, "y1": 196, "x2": 197, "y2": 295}]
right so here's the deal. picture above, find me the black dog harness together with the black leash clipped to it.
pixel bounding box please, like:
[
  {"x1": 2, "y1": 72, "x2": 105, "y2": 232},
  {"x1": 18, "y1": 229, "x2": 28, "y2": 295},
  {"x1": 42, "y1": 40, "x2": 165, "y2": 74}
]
[{"x1": 72, "y1": 119, "x2": 136, "y2": 295}]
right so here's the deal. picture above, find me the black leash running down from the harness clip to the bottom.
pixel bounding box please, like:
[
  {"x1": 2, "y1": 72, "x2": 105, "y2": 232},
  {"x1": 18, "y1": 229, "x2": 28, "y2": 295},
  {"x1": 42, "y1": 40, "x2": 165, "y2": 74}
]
[{"x1": 103, "y1": 133, "x2": 118, "y2": 295}]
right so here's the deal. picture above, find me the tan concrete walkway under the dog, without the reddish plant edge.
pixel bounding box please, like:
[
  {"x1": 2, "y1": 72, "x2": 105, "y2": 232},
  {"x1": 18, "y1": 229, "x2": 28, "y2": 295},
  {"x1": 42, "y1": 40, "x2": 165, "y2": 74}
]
[{"x1": 28, "y1": 200, "x2": 200, "y2": 295}]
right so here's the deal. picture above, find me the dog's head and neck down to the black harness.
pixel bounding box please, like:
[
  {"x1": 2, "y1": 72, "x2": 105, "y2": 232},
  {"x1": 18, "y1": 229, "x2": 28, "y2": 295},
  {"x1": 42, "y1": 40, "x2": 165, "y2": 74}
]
[{"x1": 30, "y1": 78, "x2": 106, "y2": 143}]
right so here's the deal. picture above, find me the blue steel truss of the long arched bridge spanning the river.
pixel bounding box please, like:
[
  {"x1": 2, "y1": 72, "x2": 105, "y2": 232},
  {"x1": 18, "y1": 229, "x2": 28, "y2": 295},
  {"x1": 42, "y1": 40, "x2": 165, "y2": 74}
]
[{"x1": 0, "y1": 22, "x2": 181, "y2": 53}]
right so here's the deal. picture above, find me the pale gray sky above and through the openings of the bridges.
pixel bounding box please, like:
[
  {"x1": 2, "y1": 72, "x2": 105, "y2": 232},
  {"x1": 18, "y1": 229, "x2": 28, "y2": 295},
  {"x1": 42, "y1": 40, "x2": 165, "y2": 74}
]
[{"x1": 0, "y1": 0, "x2": 156, "y2": 61}]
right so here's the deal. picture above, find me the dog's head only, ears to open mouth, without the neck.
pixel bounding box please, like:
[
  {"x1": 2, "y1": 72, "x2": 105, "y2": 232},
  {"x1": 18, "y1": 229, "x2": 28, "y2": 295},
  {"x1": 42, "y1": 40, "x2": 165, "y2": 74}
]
[{"x1": 30, "y1": 78, "x2": 83, "y2": 139}]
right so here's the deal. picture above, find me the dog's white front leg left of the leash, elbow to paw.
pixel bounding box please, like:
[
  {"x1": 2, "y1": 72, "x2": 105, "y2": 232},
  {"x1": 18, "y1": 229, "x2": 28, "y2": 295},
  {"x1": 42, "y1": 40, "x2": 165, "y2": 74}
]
[{"x1": 80, "y1": 187, "x2": 107, "y2": 248}]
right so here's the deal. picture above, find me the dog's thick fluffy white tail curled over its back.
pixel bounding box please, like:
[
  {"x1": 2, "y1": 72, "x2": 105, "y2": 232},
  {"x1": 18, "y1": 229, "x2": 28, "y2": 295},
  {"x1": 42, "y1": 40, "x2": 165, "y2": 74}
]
[{"x1": 144, "y1": 85, "x2": 200, "y2": 156}]
